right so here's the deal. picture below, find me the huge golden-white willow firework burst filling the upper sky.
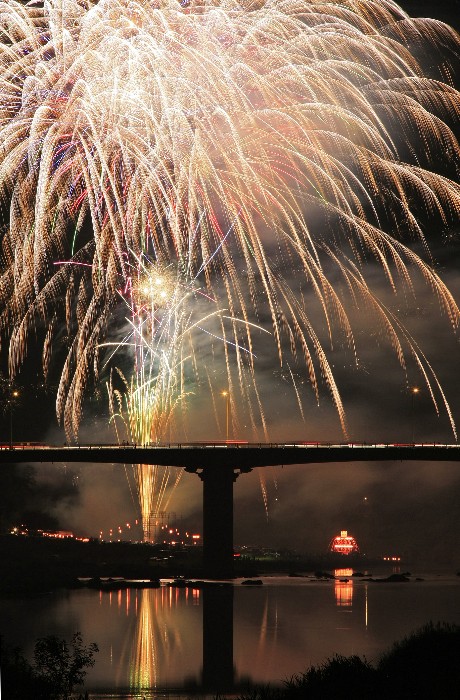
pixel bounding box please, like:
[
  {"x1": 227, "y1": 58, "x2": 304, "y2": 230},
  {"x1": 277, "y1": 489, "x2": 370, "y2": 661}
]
[{"x1": 0, "y1": 0, "x2": 460, "y2": 434}]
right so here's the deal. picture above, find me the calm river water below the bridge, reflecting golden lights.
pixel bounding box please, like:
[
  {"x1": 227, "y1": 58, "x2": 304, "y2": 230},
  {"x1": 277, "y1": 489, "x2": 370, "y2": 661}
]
[{"x1": 0, "y1": 570, "x2": 460, "y2": 698}]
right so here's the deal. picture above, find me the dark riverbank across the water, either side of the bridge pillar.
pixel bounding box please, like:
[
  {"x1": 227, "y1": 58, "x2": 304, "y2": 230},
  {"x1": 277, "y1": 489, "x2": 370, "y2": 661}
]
[{"x1": 0, "y1": 535, "x2": 416, "y2": 597}]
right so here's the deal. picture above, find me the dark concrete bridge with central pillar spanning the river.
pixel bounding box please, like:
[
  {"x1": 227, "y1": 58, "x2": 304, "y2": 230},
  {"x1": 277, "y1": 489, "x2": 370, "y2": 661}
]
[{"x1": 0, "y1": 441, "x2": 460, "y2": 578}]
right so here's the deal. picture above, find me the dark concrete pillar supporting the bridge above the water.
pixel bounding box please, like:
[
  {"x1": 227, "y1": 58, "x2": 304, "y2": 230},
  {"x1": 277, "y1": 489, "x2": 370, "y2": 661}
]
[{"x1": 199, "y1": 465, "x2": 238, "y2": 579}]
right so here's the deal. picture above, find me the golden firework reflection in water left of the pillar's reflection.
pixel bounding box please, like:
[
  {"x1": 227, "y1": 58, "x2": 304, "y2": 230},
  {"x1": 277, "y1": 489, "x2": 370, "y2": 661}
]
[{"x1": 90, "y1": 586, "x2": 202, "y2": 697}]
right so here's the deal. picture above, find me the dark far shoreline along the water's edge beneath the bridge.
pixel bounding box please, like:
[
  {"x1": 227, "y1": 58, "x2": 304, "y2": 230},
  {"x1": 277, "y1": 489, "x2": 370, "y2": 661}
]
[{"x1": 0, "y1": 535, "x2": 458, "y2": 598}]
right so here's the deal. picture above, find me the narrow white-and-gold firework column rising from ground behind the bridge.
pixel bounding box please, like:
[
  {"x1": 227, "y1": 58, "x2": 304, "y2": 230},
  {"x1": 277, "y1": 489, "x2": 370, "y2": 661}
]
[{"x1": 108, "y1": 259, "x2": 195, "y2": 541}]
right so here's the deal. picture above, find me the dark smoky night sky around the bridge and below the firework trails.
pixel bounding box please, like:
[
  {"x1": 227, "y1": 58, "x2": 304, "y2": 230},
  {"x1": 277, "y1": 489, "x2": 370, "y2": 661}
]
[{"x1": 0, "y1": 0, "x2": 460, "y2": 567}]
